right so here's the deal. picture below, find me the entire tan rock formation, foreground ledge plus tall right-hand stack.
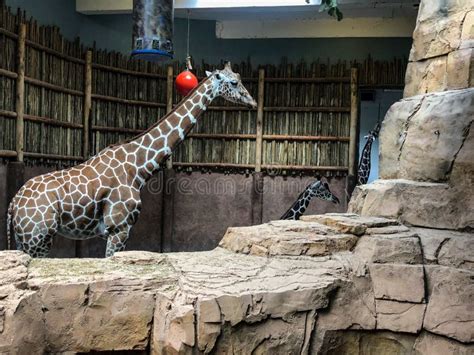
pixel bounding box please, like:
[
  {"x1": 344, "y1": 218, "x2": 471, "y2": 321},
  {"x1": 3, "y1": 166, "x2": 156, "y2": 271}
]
[{"x1": 0, "y1": 0, "x2": 474, "y2": 355}]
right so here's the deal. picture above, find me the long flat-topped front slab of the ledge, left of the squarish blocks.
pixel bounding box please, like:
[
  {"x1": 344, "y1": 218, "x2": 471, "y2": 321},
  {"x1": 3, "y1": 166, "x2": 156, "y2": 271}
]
[{"x1": 0, "y1": 246, "x2": 347, "y2": 354}]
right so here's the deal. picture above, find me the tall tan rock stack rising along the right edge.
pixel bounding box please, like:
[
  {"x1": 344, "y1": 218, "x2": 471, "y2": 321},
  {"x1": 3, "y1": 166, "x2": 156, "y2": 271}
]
[{"x1": 349, "y1": 0, "x2": 474, "y2": 230}]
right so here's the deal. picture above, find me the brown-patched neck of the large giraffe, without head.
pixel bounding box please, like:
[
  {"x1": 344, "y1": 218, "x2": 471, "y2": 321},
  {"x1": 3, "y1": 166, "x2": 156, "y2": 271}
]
[{"x1": 126, "y1": 78, "x2": 216, "y2": 182}]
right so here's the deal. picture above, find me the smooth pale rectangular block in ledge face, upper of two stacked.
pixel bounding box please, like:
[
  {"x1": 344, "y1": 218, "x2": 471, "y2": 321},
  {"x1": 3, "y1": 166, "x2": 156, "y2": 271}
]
[{"x1": 369, "y1": 264, "x2": 425, "y2": 303}]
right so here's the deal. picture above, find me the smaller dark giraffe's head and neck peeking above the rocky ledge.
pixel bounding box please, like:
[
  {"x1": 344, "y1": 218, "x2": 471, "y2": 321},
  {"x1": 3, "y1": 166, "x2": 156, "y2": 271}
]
[{"x1": 280, "y1": 179, "x2": 339, "y2": 220}]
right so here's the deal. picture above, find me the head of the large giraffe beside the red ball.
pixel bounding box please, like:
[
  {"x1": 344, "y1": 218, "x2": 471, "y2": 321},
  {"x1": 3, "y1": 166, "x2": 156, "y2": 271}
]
[{"x1": 206, "y1": 62, "x2": 257, "y2": 108}]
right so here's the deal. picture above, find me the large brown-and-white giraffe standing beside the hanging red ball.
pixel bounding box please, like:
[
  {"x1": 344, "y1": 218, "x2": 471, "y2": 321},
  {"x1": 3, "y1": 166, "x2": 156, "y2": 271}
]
[{"x1": 7, "y1": 63, "x2": 257, "y2": 257}]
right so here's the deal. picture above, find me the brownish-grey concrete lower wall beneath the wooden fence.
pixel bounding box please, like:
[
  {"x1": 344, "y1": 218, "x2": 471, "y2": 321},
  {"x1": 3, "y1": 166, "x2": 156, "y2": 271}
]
[{"x1": 0, "y1": 164, "x2": 346, "y2": 257}]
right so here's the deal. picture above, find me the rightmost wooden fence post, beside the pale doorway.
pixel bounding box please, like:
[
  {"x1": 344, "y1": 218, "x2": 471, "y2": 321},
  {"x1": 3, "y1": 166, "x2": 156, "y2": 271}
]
[{"x1": 347, "y1": 68, "x2": 359, "y2": 198}]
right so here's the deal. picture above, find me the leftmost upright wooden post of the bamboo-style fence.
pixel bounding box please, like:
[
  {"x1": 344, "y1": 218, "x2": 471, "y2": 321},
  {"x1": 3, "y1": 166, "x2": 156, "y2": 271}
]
[{"x1": 16, "y1": 23, "x2": 26, "y2": 161}]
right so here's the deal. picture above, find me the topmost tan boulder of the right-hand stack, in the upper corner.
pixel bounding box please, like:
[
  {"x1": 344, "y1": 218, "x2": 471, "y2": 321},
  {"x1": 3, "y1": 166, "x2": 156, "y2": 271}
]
[{"x1": 404, "y1": 0, "x2": 474, "y2": 97}]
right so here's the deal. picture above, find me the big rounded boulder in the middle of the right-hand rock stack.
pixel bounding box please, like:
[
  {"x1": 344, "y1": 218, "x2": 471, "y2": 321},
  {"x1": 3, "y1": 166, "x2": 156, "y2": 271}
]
[{"x1": 379, "y1": 88, "x2": 474, "y2": 182}]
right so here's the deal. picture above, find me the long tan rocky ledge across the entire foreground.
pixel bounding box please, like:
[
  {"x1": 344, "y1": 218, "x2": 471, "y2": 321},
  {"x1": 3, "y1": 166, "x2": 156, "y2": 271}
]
[{"x1": 0, "y1": 214, "x2": 474, "y2": 355}]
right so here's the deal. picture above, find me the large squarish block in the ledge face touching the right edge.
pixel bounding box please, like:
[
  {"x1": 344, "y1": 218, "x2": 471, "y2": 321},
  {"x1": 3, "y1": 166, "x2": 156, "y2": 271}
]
[{"x1": 423, "y1": 265, "x2": 474, "y2": 342}]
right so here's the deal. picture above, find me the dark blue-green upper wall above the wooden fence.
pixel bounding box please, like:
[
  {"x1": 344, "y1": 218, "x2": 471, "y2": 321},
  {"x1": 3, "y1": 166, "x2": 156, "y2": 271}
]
[{"x1": 6, "y1": 0, "x2": 412, "y2": 65}]
